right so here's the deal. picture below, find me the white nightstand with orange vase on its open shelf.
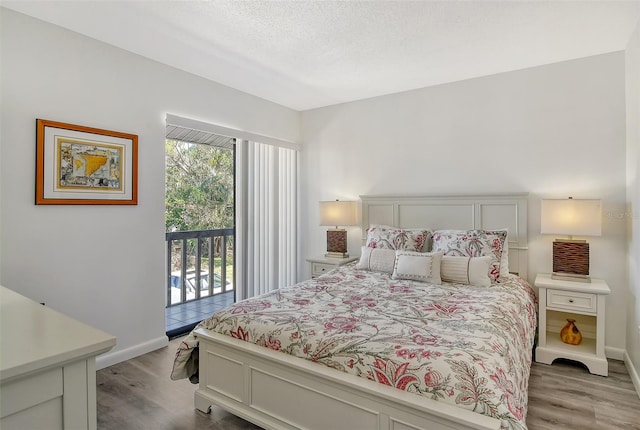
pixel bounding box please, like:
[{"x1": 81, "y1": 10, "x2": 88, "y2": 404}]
[{"x1": 535, "y1": 274, "x2": 611, "y2": 376}]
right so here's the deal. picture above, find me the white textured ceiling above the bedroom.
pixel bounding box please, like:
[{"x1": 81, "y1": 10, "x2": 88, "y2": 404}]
[{"x1": 0, "y1": 0, "x2": 640, "y2": 110}]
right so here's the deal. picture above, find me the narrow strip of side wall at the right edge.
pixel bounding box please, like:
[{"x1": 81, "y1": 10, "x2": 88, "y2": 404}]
[{"x1": 625, "y1": 19, "x2": 640, "y2": 393}]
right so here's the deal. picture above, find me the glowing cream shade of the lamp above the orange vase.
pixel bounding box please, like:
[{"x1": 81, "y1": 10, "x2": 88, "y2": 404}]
[{"x1": 540, "y1": 199, "x2": 602, "y2": 236}]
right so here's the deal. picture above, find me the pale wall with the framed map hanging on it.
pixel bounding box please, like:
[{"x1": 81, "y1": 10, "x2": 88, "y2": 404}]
[{"x1": 0, "y1": 8, "x2": 300, "y2": 364}]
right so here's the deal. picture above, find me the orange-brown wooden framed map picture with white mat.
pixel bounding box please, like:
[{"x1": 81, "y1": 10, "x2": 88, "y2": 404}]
[{"x1": 36, "y1": 119, "x2": 138, "y2": 205}]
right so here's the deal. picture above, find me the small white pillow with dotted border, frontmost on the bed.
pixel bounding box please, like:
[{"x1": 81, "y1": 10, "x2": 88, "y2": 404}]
[{"x1": 391, "y1": 250, "x2": 442, "y2": 285}]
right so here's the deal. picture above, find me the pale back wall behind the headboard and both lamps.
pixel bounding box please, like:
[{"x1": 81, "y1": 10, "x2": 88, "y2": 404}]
[{"x1": 302, "y1": 52, "x2": 627, "y2": 352}]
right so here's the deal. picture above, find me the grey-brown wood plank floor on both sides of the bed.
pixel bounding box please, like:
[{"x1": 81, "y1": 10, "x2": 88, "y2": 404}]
[{"x1": 97, "y1": 338, "x2": 640, "y2": 430}]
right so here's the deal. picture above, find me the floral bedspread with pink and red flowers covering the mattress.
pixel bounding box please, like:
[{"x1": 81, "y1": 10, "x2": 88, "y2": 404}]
[{"x1": 171, "y1": 265, "x2": 536, "y2": 429}]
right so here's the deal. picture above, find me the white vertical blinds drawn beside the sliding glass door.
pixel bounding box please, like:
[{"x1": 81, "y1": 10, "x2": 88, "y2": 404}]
[{"x1": 236, "y1": 140, "x2": 298, "y2": 300}]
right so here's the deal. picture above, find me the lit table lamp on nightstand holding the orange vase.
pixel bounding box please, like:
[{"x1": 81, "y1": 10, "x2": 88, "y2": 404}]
[{"x1": 540, "y1": 197, "x2": 602, "y2": 282}]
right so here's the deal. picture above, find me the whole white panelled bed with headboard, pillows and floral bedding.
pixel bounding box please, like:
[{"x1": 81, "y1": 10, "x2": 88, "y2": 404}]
[{"x1": 172, "y1": 194, "x2": 536, "y2": 430}]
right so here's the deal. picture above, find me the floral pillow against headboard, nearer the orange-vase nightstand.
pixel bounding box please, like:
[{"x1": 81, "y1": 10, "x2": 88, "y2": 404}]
[{"x1": 432, "y1": 230, "x2": 507, "y2": 282}]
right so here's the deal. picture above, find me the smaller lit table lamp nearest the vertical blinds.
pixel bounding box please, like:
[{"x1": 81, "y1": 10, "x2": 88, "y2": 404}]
[{"x1": 320, "y1": 200, "x2": 356, "y2": 258}]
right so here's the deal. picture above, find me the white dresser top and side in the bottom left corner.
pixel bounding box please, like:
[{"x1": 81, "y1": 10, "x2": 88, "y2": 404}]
[{"x1": 0, "y1": 286, "x2": 116, "y2": 430}]
